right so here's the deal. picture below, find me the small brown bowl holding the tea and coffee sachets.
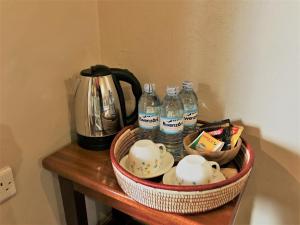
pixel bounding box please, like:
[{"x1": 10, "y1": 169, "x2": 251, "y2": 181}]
[{"x1": 183, "y1": 132, "x2": 242, "y2": 165}]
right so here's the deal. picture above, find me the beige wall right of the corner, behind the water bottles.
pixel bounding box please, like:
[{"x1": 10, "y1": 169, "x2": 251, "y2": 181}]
[{"x1": 99, "y1": 0, "x2": 300, "y2": 225}]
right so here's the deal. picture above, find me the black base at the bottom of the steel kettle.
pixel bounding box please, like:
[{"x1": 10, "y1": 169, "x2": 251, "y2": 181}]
[{"x1": 77, "y1": 134, "x2": 115, "y2": 151}]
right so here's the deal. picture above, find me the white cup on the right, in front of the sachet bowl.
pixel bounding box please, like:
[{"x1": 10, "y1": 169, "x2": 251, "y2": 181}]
[{"x1": 176, "y1": 155, "x2": 220, "y2": 185}]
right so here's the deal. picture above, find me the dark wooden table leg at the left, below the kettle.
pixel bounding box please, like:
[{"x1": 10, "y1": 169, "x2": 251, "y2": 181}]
[{"x1": 58, "y1": 176, "x2": 88, "y2": 225}]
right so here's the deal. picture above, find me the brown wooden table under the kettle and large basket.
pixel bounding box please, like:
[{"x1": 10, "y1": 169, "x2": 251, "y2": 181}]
[{"x1": 43, "y1": 144, "x2": 241, "y2": 225}]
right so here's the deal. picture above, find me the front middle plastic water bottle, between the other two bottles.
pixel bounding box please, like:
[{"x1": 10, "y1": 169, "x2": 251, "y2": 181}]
[{"x1": 160, "y1": 86, "x2": 183, "y2": 162}]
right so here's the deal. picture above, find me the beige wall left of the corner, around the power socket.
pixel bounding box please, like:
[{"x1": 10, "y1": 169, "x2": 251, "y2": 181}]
[{"x1": 0, "y1": 0, "x2": 100, "y2": 225}]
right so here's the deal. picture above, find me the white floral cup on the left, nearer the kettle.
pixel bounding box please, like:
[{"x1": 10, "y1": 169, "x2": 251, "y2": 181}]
[{"x1": 127, "y1": 139, "x2": 166, "y2": 177}]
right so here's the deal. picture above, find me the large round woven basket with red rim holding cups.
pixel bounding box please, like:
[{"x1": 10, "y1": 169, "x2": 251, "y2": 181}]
[{"x1": 110, "y1": 126, "x2": 254, "y2": 213}]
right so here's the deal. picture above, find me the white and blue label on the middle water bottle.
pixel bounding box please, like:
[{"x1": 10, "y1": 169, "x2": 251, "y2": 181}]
[{"x1": 160, "y1": 117, "x2": 183, "y2": 134}]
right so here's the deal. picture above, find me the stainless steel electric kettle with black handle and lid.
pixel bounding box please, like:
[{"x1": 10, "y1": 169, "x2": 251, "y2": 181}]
[{"x1": 75, "y1": 65, "x2": 142, "y2": 150}]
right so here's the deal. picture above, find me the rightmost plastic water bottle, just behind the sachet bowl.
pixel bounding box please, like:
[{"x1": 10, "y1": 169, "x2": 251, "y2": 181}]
[{"x1": 179, "y1": 81, "x2": 198, "y2": 136}]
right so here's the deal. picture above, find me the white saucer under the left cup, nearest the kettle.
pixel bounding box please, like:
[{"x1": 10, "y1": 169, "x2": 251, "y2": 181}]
[{"x1": 120, "y1": 152, "x2": 174, "y2": 179}]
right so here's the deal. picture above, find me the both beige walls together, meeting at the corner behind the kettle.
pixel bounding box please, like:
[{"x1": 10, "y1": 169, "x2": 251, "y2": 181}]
[{"x1": 0, "y1": 0, "x2": 300, "y2": 224}]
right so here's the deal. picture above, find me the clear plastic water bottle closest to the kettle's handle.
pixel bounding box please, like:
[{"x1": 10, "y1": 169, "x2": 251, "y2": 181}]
[{"x1": 138, "y1": 84, "x2": 160, "y2": 142}]
